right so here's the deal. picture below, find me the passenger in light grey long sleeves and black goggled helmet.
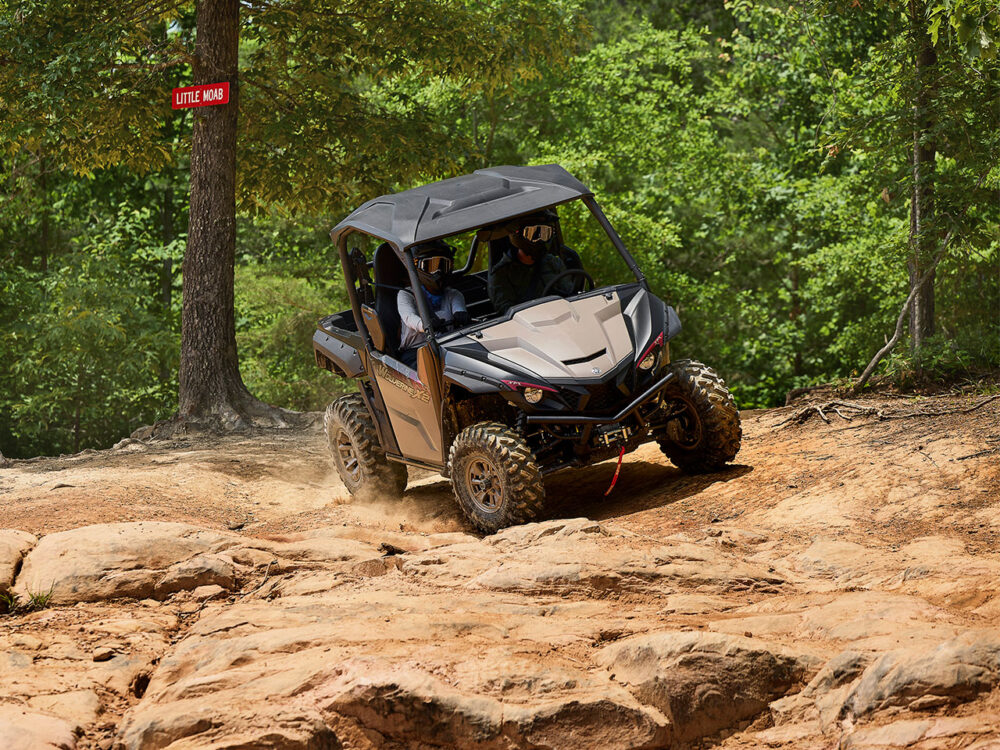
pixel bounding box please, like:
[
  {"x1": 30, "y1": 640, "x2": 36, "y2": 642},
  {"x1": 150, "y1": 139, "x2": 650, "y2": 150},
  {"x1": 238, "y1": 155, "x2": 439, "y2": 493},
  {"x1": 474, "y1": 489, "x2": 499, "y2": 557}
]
[{"x1": 396, "y1": 240, "x2": 469, "y2": 369}]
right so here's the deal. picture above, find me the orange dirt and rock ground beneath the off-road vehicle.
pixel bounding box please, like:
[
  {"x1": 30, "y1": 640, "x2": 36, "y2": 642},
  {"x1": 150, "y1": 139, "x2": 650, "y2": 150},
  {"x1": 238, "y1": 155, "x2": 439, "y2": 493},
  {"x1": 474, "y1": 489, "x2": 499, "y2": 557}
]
[{"x1": 0, "y1": 397, "x2": 1000, "y2": 750}]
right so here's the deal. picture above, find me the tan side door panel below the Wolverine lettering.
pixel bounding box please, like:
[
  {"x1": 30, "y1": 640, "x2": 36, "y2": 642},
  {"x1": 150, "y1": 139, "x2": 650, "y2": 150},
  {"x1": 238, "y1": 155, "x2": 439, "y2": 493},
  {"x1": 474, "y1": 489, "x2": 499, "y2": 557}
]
[{"x1": 372, "y1": 355, "x2": 442, "y2": 465}]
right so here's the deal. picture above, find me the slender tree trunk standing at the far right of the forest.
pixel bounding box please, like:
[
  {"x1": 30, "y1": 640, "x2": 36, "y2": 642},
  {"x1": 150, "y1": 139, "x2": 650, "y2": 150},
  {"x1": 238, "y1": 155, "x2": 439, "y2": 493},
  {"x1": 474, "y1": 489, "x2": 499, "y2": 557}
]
[{"x1": 907, "y1": 0, "x2": 937, "y2": 352}]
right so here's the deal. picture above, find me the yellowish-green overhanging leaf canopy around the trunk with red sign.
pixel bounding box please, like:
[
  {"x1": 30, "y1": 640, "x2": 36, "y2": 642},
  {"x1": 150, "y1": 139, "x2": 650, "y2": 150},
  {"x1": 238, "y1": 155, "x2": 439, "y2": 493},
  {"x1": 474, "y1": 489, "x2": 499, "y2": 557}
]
[{"x1": 0, "y1": 0, "x2": 583, "y2": 212}]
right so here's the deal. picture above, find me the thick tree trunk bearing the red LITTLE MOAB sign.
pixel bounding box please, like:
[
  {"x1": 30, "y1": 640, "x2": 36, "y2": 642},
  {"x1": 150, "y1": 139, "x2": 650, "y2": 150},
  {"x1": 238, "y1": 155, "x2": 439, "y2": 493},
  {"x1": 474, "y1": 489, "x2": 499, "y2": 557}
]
[{"x1": 179, "y1": 0, "x2": 270, "y2": 427}]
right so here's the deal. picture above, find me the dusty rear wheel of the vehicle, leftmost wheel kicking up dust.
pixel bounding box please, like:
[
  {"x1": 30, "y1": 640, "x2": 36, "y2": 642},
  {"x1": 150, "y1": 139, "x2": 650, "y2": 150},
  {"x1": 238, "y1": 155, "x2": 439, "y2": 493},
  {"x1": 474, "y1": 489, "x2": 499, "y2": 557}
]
[{"x1": 323, "y1": 393, "x2": 406, "y2": 500}]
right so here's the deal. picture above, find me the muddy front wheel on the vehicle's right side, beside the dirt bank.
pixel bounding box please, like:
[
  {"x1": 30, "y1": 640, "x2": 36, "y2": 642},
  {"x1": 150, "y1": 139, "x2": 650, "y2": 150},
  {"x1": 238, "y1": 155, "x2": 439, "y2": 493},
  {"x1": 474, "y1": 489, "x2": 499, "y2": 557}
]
[{"x1": 656, "y1": 359, "x2": 743, "y2": 474}]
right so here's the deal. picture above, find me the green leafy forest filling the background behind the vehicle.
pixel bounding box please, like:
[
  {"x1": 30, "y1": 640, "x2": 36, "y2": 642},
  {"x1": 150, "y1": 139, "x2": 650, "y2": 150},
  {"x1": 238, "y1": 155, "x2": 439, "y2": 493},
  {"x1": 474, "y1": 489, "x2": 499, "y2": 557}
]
[{"x1": 0, "y1": 0, "x2": 1000, "y2": 457}]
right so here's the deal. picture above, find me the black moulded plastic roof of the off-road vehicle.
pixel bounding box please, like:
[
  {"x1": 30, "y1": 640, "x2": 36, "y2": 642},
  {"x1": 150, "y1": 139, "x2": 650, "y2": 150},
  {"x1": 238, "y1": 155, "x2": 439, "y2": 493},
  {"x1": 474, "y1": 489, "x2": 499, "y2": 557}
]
[{"x1": 330, "y1": 164, "x2": 592, "y2": 250}]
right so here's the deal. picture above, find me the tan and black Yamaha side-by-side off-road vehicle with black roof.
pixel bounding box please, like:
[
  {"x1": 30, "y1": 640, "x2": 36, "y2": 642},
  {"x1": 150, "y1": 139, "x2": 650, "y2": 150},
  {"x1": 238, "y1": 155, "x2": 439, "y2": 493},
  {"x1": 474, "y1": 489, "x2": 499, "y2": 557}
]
[{"x1": 313, "y1": 164, "x2": 741, "y2": 532}]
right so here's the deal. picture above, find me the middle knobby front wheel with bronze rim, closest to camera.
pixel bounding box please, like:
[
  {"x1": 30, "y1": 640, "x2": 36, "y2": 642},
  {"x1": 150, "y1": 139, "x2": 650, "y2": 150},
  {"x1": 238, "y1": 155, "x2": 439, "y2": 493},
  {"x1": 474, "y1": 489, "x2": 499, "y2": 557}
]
[{"x1": 448, "y1": 422, "x2": 545, "y2": 534}]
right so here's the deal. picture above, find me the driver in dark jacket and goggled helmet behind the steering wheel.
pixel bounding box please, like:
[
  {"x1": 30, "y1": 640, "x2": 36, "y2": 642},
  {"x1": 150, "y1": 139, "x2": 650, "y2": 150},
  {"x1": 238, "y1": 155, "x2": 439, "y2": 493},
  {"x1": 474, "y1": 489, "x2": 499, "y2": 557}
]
[{"x1": 489, "y1": 211, "x2": 574, "y2": 314}]
